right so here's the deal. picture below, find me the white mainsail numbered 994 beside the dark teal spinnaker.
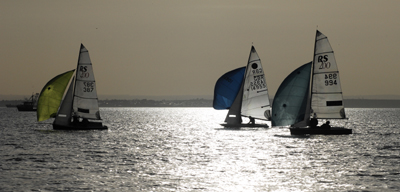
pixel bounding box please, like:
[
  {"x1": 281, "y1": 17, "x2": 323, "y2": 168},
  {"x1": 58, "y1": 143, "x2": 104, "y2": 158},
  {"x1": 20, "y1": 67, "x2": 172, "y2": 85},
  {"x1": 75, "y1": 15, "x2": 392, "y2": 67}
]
[{"x1": 311, "y1": 30, "x2": 346, "y2": 119}]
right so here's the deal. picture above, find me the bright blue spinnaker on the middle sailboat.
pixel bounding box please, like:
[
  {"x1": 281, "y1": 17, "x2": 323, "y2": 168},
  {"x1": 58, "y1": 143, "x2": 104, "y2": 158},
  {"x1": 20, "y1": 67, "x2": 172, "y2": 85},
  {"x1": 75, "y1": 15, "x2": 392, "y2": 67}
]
[{"x1": 213, "y1": 67, "x2": 246, "y2": 109}]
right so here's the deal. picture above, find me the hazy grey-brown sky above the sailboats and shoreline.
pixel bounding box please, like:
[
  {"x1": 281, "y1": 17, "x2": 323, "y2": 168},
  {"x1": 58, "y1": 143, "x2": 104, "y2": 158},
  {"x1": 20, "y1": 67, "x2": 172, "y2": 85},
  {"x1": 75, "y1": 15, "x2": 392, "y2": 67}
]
[{"x1": 0, "y1": 0, "x2": 400, "y2": 99}]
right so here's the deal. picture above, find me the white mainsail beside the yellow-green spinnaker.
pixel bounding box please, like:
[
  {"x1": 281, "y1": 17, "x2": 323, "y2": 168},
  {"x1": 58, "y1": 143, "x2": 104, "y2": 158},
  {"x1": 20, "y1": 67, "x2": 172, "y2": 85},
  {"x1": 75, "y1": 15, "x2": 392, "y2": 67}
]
[{"x1": 73, "y1": 45, "x2": 100, "y2": 120}]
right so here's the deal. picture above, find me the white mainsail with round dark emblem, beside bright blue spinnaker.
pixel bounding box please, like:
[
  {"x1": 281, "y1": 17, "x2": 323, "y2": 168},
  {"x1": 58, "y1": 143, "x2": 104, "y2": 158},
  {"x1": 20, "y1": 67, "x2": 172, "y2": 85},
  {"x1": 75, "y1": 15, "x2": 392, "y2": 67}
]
[{"x1": 242, "y1": 46, "x2": 271, "y2": 120}]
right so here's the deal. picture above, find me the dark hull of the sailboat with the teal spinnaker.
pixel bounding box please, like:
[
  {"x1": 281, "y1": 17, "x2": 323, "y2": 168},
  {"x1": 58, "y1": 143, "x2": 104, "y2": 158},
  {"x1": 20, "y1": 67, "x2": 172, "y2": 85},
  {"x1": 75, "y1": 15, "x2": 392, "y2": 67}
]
[{"x1": 289, "y1": 127, "x2": 353, "y2": 135}]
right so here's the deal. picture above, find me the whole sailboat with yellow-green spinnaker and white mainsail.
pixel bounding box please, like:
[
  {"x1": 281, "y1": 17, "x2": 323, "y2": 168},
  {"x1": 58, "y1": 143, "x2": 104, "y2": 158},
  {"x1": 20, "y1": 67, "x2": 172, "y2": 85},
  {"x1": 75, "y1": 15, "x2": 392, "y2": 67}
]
[{"x1": 37, "y1": 44, "x2": 107, "y2": 130}]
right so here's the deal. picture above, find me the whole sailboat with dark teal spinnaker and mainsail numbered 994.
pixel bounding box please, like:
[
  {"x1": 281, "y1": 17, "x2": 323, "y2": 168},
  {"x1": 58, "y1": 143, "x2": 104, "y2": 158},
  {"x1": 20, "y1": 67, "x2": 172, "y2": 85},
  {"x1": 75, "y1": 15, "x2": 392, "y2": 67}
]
[{"x1": 271, "y1": 30, "x2": 352, "y2": 135}]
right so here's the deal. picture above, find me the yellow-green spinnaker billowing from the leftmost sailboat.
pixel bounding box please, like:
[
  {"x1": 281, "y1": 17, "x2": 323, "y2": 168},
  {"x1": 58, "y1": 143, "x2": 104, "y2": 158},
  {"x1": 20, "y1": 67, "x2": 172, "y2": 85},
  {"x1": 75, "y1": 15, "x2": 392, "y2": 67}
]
[{"x1": 36, "y1": 70, "x2": 75, "y2": 121}]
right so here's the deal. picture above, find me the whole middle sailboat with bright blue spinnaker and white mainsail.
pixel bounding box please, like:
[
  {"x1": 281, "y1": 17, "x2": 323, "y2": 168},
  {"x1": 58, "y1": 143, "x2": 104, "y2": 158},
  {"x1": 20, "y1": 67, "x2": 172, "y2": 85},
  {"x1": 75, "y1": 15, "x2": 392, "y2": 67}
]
[{"x1": 213, "y1": 46, "x2": 271, "y2": 127}]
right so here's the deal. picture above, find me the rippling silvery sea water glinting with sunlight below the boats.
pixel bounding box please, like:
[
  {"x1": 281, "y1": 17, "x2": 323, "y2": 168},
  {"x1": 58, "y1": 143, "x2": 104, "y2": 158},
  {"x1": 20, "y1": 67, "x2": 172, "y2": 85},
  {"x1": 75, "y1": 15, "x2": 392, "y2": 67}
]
[{"x1": 0, "y1": 108, "x2": 400, "y2": 191}]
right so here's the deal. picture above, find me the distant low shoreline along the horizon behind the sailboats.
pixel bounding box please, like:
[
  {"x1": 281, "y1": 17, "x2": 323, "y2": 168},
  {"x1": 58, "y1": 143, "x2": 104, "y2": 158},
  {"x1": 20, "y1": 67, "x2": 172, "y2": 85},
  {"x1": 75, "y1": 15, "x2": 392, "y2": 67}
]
[{"x1": 0, "y1": 99, "x2": 400, "y2": 108}]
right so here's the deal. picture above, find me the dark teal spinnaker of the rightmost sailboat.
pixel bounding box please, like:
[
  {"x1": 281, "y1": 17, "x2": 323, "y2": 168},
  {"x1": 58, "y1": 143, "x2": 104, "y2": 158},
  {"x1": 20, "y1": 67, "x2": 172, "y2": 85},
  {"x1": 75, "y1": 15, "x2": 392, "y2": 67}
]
[{"x1": 271, "y1": 62, "x2": 312, "y2": 126}]
